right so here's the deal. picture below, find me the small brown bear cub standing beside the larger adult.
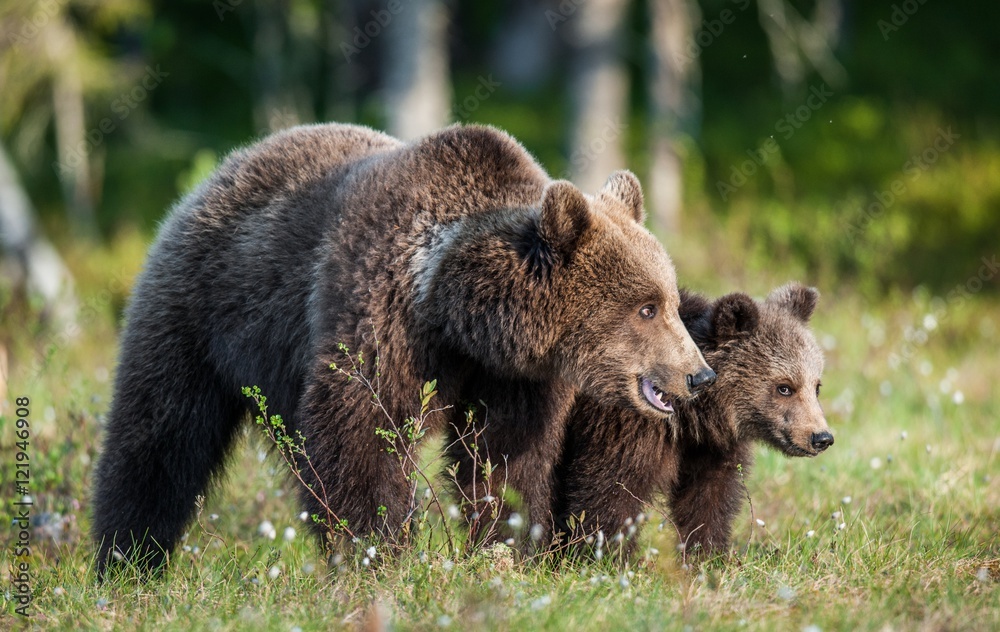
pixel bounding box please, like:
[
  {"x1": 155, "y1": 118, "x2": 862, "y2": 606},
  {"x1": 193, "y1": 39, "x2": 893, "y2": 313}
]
[{"x1": 555, "y1": 284, "x2": 833, "y2": 555}]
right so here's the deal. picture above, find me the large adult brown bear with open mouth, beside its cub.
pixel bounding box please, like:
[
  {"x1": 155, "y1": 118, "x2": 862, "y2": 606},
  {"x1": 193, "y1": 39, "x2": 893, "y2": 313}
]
[{"x1": 94, "y1": 124, "x2": 714, "y2": 573}]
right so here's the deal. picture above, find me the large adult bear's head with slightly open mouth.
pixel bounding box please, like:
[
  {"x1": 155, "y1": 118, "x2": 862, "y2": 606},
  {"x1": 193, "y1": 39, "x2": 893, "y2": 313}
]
[{"x1": 417, "y1": 171, "x2": 715, "y2": 419}]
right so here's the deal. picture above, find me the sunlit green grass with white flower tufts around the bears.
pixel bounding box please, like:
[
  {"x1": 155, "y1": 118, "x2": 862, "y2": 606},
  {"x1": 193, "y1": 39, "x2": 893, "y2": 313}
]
[{"x1": 0, "y1": 235, "x2": 1000, "y2": 630}]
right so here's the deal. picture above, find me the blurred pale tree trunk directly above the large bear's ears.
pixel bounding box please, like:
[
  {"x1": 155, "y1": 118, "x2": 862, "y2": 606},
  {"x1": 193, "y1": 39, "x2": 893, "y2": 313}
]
[{"x1": 568, "y1": 0, "x2": 628, "y2": 192}]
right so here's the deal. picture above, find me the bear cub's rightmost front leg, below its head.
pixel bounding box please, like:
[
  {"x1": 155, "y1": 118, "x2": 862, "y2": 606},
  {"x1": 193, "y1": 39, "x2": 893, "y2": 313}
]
[{"x1": 668, "y1": 443, "x2": 753, "y2": 554}]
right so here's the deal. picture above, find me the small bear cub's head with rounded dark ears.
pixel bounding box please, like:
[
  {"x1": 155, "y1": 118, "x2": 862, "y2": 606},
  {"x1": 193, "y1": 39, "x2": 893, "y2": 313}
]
[{"x1": 682, "y1": 283, "x2": 833, "y2": 456}]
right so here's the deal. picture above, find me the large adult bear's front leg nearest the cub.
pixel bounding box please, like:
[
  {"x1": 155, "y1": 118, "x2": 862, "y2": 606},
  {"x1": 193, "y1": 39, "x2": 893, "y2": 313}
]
[{"x1": 448, "y1": 376, "x2": 575, "y2": 549}]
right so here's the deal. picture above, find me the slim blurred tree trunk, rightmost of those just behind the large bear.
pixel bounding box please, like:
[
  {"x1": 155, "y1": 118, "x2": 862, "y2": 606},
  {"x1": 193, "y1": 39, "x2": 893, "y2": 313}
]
[{"x1": 646, "y1": 0, "x2": 701, "y2": 235}]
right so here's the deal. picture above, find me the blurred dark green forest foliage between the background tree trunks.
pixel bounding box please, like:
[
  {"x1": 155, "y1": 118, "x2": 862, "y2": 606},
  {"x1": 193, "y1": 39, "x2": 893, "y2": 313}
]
[{"x1": 0, "y1": 0, "x2": 1000, "y2": 296}]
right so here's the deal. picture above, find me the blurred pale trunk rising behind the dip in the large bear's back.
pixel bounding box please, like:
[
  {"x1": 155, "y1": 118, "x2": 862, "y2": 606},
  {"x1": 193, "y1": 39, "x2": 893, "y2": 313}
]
[{"x1": 382, "y1": 0, "x2": 451, "y2": 140}]
